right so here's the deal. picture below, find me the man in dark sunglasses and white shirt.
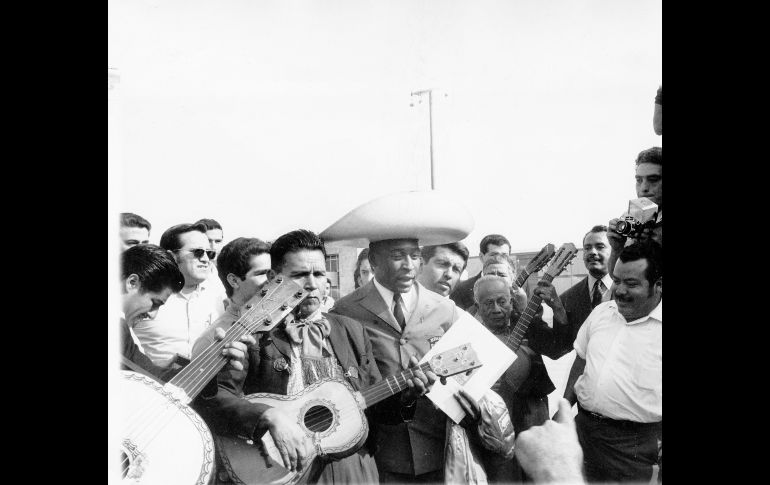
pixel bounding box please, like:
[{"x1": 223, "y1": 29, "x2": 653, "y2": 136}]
[{"x1": 133, "y1": 224, "x2": 224, "y2": 367}]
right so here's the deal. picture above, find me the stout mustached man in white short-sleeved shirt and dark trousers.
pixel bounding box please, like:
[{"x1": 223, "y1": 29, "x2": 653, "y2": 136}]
[{"x1": 564, "y1": 241, "x2": 663, "y2": 482}]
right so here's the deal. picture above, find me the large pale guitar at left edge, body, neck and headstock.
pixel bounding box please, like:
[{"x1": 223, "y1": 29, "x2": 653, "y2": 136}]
[{"x1": 119, "y1": 276, "x2": 307, "y2": 485}]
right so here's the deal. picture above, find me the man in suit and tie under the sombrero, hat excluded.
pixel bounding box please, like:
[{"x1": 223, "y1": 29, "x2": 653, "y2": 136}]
[{"x1": 332, "y1": 239, "x2": 459, "y2": 483}]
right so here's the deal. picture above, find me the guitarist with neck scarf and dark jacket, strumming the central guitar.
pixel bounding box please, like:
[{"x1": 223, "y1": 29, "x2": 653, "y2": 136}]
[{"x1": 193, "y1": 229, "x2": 382, "y2": 484}]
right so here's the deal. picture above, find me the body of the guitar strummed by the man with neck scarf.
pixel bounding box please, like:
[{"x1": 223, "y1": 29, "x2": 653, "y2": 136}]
[{"x1": 216, "y1": 379, "x2": 369, "y2": 485}]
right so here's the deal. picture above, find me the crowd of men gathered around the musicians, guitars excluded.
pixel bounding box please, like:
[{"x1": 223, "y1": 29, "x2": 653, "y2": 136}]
[{"x1": 120, "y1": 92, "x2": 663, "y2": 484}]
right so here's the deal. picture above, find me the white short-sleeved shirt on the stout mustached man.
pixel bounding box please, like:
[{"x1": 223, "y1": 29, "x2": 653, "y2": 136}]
[{"x1": 574, "y1": 300, "x2": 663, "y2": 423}]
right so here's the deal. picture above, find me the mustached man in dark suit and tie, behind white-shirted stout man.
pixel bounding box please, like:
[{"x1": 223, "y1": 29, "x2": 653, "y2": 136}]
[{"x1": 554, "y1": 225, "x2": 612, "y2": 356}]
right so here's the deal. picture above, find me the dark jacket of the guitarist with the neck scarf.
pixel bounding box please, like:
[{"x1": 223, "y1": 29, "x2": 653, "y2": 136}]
[{"x1": 193, "y1": 314, "x2": 382, "y2": 439}]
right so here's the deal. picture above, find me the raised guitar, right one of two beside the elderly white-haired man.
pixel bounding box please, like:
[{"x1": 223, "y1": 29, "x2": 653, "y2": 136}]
[{"x1": 493, "y1": 243, "x2": 578, "y2": 391}]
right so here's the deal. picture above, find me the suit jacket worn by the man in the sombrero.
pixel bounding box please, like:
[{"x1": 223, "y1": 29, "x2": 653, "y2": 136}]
[{"x1": 331, "y1": 281, "x2": 460, "y2": 475}]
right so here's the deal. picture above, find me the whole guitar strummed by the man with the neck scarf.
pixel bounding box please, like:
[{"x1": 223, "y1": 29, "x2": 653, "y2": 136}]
[{"x1": 216, "y1": 344, "x2": 482, "y2": 485}]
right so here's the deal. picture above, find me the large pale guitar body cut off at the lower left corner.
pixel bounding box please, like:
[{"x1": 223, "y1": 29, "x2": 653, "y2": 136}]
[{"x1": 120, "y1": 371, "x2": 214, "y2": 485}]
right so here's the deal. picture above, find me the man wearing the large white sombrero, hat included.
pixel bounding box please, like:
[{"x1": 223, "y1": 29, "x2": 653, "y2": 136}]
[{"x1": 320, "y1": 192, "x2": 473, "y2": 483}]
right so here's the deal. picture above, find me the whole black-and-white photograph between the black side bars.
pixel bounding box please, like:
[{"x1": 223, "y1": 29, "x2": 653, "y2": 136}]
[{"x1": 108, "y1": 0, "x2": 660, "y2": 485}]
